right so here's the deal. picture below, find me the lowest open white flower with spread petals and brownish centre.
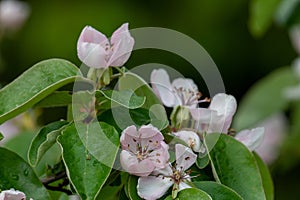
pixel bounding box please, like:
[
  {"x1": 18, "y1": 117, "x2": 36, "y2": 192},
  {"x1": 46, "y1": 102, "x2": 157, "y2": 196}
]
[{"x1": 137, "y1": 144, "x2": 197, "y2": 200}]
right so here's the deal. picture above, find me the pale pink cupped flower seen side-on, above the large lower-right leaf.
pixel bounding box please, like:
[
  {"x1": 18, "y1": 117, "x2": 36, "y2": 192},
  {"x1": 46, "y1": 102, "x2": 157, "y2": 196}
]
[{"x1": 190, "y1": 93, "x2": 237, "y2": 133}]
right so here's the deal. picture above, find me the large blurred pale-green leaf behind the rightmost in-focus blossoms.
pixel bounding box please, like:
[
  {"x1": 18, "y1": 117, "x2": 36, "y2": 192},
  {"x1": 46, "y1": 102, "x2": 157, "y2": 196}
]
[{"x1": 233, "y1": 67, "x2": 297, "y2": 130}]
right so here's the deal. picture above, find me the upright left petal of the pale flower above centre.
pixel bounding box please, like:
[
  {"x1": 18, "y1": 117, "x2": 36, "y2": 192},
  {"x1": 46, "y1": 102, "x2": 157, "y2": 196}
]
[{"x1": 150, "y1": 69, "x2": 177, "y2": 107}]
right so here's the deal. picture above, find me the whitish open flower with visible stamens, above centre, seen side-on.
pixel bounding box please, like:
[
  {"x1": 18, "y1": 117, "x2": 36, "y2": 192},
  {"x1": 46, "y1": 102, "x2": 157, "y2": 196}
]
[{"x1": 150, "y1": 69, "x2": 201, "y2": 108}]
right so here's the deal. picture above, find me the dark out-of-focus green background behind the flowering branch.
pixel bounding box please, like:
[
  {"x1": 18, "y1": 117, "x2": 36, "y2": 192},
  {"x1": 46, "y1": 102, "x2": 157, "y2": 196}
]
[{"x1": 0, "y1": 0, "x2": 300, "y2": 199}]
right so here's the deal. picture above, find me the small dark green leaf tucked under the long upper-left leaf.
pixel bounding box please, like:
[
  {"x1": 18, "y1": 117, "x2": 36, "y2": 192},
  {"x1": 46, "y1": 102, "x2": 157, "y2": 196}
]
[{"x1": 35, "y1": 91, "x2": 72, "y2": 108}]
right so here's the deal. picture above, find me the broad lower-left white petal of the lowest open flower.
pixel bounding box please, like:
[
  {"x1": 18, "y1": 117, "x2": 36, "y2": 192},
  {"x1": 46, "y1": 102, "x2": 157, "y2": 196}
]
[{"x1": 137, "y1": 176, "x2": 174, "y2": 200}]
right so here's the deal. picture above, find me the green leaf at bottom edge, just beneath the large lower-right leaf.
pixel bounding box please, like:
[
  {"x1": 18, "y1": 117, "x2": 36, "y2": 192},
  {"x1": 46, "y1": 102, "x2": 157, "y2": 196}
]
[{"x1": 193, "y1": 181, "x2": 243, "y2": 200}]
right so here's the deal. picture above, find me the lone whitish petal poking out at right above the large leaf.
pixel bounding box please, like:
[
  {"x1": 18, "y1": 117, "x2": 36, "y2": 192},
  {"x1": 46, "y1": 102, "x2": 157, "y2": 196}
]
[{"x1": 235, "y1": 127, "x2": 264, "y2": 151}]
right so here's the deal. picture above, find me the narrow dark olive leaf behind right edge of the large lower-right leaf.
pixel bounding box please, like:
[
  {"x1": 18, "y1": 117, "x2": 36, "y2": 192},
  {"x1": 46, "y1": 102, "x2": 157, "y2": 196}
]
[{"x1": 253, "y1": 152, "x2": 274, "y2": 200}]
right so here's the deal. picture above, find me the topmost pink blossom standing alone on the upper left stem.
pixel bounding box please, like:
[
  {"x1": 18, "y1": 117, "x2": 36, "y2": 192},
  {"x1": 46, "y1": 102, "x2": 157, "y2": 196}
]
[{"x1": 77, "y1": 23, "x2": 134, "y2": 68}]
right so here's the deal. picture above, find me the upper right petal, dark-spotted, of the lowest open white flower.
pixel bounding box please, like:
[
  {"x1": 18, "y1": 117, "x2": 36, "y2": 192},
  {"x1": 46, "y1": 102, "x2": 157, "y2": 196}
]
[{"x1": 175, "y1": 144, "x2": 197, "y2": 171}]
